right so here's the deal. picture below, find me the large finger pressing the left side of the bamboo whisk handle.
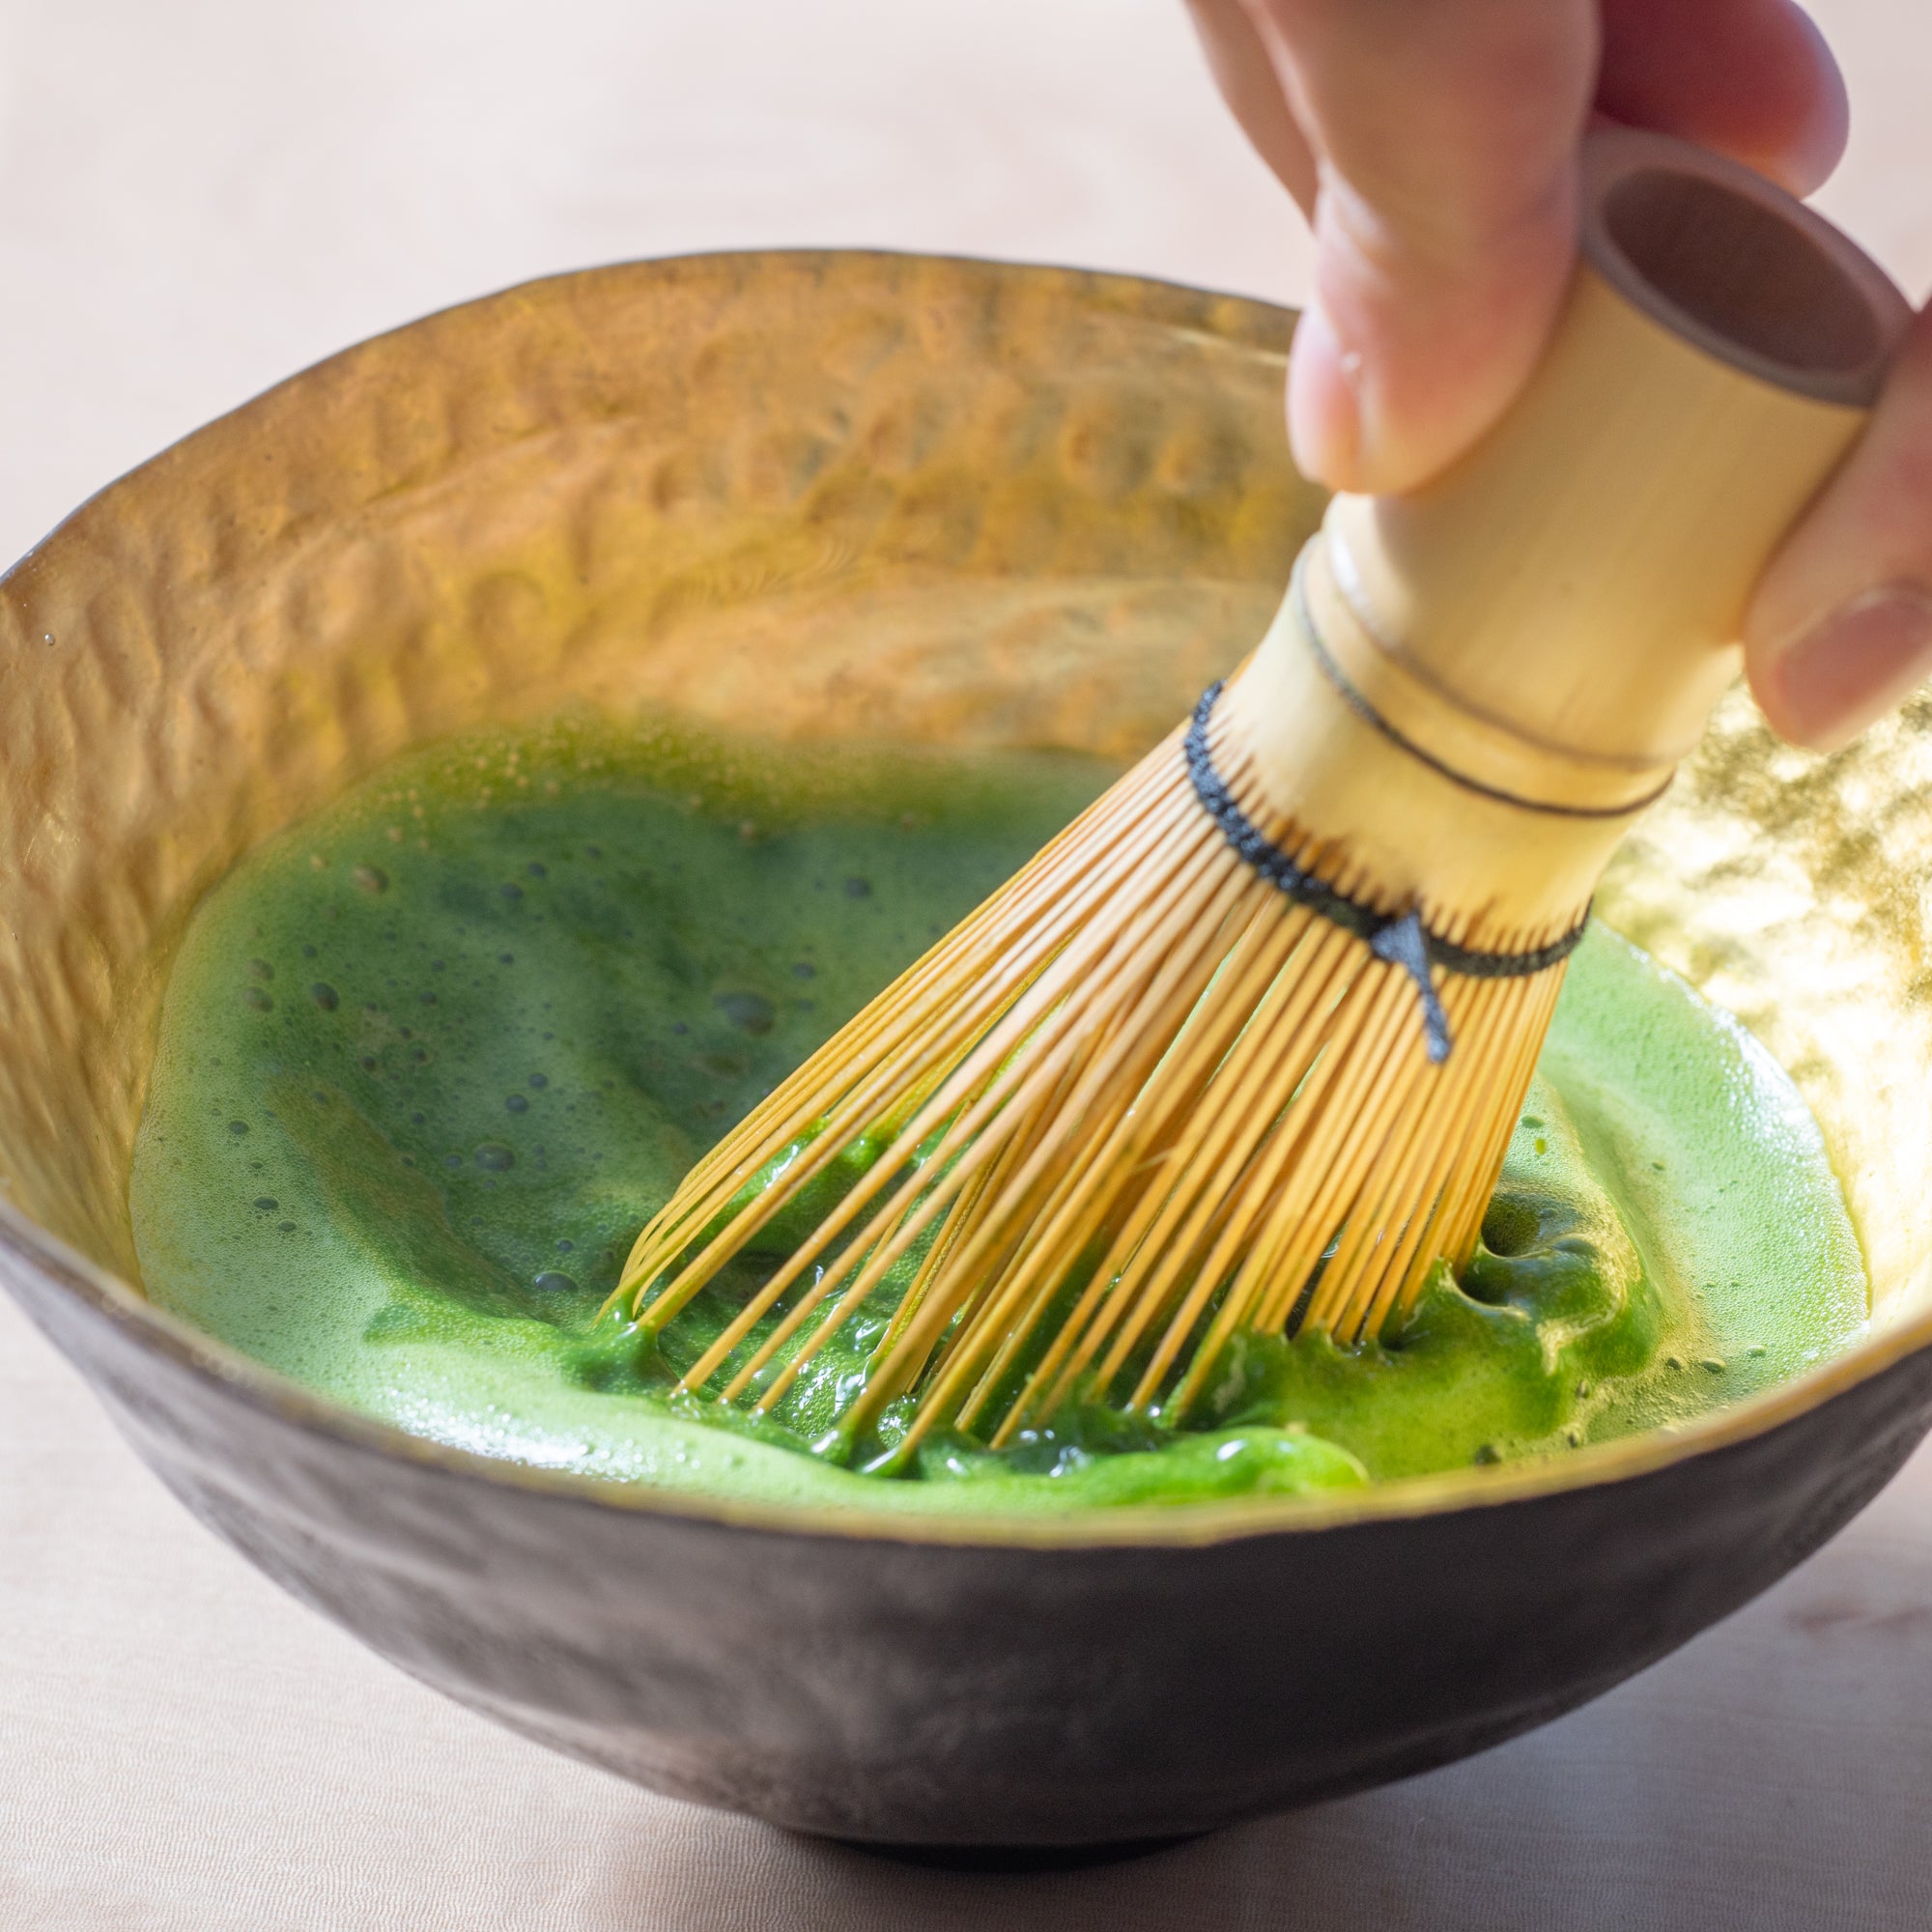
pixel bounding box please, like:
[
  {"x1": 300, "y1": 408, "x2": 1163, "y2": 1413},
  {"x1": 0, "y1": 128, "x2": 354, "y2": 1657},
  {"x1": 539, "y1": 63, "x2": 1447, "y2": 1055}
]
[{"x1": 1246, "y1": 0, "x2": 1598, "y2": 491}]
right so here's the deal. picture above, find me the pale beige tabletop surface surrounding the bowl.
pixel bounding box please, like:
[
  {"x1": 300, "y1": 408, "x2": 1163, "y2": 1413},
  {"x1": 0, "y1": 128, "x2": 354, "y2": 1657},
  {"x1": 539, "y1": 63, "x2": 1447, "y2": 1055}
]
[{"x1": 0, "y1": 0, "x2": 1932, "y2": 1932}]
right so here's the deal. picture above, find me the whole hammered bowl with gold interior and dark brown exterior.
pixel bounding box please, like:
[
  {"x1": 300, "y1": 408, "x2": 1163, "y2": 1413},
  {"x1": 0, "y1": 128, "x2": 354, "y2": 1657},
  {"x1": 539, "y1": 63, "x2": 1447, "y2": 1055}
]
[{"x1": 0, "y1": 255, "x2": 1932, "y2": 1847}]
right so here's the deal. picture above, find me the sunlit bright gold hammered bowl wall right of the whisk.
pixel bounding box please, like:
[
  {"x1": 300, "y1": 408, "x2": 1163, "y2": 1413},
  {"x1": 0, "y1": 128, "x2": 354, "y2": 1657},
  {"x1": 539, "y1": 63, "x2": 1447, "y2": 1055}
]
[{"x1": 1598, "y1": 688, "x2": 1932, "y2": 1329}]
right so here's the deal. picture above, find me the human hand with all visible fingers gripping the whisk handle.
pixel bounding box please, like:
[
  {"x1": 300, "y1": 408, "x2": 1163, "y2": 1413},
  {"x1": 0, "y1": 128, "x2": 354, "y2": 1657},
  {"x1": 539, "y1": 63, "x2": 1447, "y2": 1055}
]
[{"x1": 1188, "y1": 0, "x2": 1932, "y2": 750}]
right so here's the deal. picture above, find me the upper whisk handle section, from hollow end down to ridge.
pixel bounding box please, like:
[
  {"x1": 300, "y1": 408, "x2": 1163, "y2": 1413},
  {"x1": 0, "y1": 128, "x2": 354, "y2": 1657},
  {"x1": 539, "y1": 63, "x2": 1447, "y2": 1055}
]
[{"x1": 1318, "y1": 129, "x2": 1911, "y2": 777}]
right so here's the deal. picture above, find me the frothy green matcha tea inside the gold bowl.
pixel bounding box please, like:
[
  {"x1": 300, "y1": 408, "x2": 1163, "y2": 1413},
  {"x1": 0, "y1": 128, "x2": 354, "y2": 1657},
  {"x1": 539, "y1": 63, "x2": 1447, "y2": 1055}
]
[{"x1": 131, "y1": 724, "x2": 1866, "y2": 1511}]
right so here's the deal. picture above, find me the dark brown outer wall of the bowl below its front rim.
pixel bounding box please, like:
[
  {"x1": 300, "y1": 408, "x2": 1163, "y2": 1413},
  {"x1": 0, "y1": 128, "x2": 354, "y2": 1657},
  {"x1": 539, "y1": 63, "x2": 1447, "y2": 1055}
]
[{"x1": 0, "y1": 1244, "x2": 1932, "y2": 1847}]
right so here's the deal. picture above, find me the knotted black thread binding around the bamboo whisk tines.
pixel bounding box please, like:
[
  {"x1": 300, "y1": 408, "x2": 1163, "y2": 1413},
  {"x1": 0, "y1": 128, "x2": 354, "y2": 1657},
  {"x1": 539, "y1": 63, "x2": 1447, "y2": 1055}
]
[{"x1": 1184, "y1": 682, "x2": 1590, "y2": 1065}]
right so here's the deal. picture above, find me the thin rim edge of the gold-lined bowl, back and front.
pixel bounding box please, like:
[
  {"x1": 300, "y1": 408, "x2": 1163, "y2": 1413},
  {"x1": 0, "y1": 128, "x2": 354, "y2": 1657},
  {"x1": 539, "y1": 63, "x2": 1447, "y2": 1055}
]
[{"x1": 0, "y1": 247, "x2": 1932, "y2": 1549}]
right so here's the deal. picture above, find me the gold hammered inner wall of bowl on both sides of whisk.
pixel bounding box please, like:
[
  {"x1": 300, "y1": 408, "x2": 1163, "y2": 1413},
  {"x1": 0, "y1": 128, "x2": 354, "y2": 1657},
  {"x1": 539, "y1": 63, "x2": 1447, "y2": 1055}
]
[{"x1": 0, "y1": 253, "x2": 1932, "y2": 1538}]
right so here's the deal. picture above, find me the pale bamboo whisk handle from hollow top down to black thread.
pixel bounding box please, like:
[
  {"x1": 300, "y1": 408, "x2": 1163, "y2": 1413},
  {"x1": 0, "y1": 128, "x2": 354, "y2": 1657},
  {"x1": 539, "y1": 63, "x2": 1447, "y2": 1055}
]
[{"x1": 1231, "y1": 129, "x2": 1911, "y2": 945}]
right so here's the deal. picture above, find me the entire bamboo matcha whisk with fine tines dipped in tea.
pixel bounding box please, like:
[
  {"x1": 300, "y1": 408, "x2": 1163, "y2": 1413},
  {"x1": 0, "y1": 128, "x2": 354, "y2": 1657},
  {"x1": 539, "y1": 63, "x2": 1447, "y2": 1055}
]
[{"x1": 616, "y1": 131, "x2": 1907, "y2": 1457}]
